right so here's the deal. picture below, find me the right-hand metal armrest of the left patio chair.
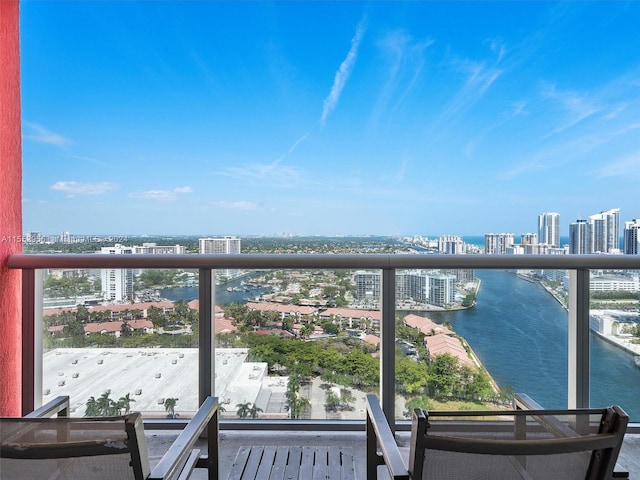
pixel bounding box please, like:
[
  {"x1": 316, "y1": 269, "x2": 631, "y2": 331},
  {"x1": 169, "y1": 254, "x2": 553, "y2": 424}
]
[{"x1": 149, "y1": 397, "x2": 218, "y2": 480}]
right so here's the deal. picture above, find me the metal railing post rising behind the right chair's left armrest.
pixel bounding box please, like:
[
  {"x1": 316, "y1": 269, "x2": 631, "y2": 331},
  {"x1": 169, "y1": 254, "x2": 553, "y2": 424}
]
[{"x1": 380, "y1": 268, "x2": 396, "y2": 431}]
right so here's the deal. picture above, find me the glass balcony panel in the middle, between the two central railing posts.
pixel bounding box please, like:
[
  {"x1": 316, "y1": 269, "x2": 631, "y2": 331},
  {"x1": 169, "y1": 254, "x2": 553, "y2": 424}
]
[{"x1": 215, "y1": 270, "x2": 380, "y2": 420}]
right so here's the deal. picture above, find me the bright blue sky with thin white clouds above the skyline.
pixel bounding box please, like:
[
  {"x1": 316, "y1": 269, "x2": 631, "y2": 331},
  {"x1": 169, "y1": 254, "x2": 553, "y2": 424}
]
[{"x1": 21, "y1": 0, "x2": 640, "y2": 235}]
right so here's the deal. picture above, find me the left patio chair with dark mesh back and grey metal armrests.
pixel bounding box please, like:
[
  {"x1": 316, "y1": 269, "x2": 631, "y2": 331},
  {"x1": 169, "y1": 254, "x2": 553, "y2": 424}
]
[{"x1": 0, "y1": 397, "x2": 218, "y2": 480}]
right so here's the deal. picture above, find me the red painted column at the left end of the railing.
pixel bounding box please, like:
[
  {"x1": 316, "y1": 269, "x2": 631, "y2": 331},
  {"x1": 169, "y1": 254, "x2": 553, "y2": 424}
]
[{"x1": 0, "y1": 0, "x2": 22, "y2": 416}]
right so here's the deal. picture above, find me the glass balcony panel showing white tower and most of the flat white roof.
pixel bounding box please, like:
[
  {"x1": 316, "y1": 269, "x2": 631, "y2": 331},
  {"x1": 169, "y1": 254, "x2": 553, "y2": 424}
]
[{"x1": 42, "y1": 269, "x2": 198, "y2": 417}]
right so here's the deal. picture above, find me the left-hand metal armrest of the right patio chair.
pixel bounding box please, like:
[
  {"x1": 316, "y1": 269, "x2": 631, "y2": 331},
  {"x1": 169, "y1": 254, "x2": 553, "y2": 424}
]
[{"x1": 366, "y1": 395, "x2": 409, "y2": 480}]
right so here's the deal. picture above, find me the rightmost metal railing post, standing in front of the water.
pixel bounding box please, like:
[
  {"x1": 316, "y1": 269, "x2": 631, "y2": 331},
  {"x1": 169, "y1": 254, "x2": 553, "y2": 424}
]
[{"x1": 568, "y1": 268, "x2": 590, "y2": 408}]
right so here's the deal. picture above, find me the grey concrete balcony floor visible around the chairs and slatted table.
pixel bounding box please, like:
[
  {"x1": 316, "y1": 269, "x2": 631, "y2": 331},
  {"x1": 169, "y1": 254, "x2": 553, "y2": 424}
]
[{"x1": 147, "y1": 430, "x2": 640, "y2": 480}]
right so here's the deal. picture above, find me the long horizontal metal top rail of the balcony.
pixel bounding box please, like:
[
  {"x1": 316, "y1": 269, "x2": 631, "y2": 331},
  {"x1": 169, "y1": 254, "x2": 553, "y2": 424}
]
[{"x1": 7, "y1": 254, "x2": 640, "y2": 270}]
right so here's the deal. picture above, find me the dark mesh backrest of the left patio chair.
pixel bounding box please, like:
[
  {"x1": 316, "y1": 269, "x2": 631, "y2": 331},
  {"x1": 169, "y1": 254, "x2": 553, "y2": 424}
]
[{"x1": 0, "y1": 413, "x2": 150, "y2": 480}]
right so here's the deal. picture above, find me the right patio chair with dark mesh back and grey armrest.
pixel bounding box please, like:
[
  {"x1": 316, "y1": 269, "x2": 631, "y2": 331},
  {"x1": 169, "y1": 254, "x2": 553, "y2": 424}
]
[{"x1": 366, "y1": 395, "x2": 628, "y2": 480}]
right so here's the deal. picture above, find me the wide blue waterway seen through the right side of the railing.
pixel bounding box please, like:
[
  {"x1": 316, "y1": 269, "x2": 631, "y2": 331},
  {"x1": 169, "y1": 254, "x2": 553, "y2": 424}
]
[{"x1": 427, "y1": 270, "x2": 640, "y2": 421}]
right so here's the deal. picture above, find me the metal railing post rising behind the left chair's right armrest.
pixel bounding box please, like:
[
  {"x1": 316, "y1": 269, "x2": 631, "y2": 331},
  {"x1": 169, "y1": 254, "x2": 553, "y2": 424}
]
[{"x1": 198, "y1": 268, "x2": 216, "y2": 405}]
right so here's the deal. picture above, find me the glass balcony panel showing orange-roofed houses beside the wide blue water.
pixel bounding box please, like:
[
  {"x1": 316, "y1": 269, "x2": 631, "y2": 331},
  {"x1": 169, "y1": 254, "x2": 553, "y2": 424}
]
[{"x1": 396, "y1": 270, "x2": 568, "y2": 419}]
